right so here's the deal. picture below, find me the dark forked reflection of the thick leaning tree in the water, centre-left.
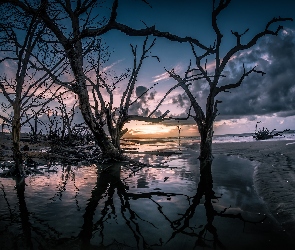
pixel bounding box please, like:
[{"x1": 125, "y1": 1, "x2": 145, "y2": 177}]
[{"x1": 79, "y1": 164, "x2": 163, "y2": 249}]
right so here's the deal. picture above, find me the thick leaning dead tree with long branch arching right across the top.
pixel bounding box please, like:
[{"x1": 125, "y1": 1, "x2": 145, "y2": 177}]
[{"x1": 3, "y1": 0, "x2": 227, "y2": 159}]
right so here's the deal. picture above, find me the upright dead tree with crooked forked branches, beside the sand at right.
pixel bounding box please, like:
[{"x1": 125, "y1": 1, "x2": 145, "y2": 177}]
[{"x1": 166, "y1": 0, "x2": 292, "y2": 172}]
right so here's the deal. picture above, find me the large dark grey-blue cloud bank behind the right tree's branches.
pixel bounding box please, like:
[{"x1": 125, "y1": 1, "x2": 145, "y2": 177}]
[{"x1": 193, "y1": 30, "x2": 295, "y2": 120}]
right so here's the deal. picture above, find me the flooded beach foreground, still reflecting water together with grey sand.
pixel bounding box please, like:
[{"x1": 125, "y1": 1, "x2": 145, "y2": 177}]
[{"x1": 0, "y1": 135, "x2": 295, "y2": 249}]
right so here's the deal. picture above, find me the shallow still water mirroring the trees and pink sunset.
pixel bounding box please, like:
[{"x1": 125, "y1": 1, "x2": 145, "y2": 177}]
[{"x1": 0, "y1": 142, "x2": 292, "y2": 249}]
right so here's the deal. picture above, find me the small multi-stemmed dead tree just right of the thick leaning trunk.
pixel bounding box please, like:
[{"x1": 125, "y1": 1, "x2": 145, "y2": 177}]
[{"x1": 87, "y1": 37, "x2": 169, "y2": 153}]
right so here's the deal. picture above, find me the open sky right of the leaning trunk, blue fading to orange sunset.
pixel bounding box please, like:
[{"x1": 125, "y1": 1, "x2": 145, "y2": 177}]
[{"x1": 0, "y1": 0, "x2": 295, "y2": 137}]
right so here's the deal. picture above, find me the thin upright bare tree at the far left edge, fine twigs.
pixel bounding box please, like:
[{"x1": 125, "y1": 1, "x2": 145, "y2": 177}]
[{"x1": 0, "y1": 7, "x2": 61, "y2": 175}]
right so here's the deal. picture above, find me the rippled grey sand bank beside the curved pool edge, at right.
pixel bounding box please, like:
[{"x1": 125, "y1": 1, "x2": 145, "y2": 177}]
[{"x1": 213, "y1": 140, "x2": 295, "y2": 236}]
